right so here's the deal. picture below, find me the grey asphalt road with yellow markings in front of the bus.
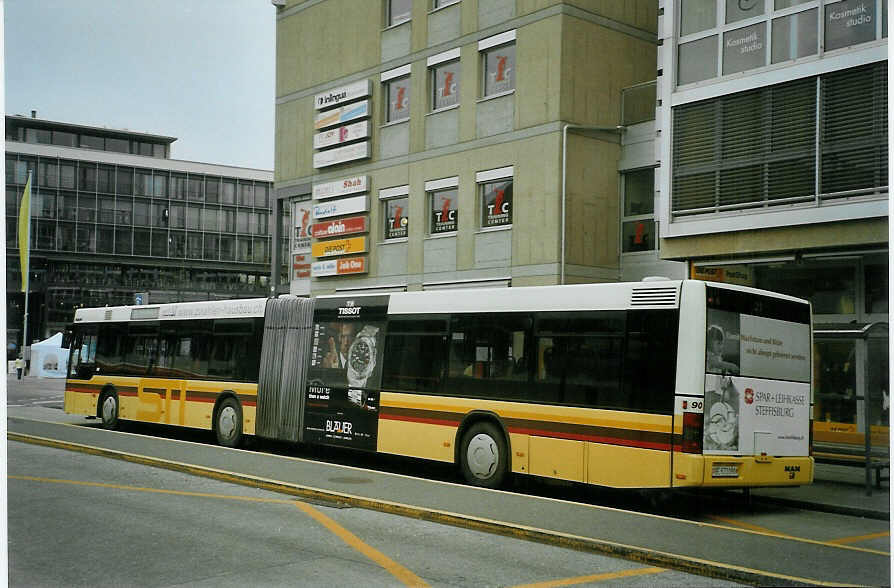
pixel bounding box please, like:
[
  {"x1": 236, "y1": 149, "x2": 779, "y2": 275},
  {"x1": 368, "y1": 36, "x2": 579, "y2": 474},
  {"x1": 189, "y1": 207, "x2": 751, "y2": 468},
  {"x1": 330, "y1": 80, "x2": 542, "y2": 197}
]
[{"x1": 3, "y1": 374, "x2": 890, "y2": 586}]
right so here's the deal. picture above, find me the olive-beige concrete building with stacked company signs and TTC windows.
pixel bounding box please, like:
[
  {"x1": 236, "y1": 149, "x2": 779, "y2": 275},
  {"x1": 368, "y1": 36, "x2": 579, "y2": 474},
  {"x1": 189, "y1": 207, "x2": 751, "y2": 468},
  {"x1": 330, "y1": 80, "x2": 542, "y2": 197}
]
[{"x1": 274, "y1": 0, "x2": 658, "y2": 295}]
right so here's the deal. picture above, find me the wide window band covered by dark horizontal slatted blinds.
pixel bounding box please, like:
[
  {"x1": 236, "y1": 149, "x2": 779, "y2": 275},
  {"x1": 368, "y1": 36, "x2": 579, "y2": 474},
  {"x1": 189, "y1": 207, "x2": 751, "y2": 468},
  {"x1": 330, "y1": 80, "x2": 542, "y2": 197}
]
[{"x1": 671, "y1": 62, "x2": 888, "y2": 216}]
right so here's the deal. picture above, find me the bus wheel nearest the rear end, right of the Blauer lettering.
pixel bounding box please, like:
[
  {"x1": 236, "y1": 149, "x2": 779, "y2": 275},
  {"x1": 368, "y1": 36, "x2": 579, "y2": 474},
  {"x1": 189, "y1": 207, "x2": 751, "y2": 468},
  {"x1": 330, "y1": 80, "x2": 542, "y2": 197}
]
[{"x1": 459, "y1": 421, "x2": 509, "y2": 488}]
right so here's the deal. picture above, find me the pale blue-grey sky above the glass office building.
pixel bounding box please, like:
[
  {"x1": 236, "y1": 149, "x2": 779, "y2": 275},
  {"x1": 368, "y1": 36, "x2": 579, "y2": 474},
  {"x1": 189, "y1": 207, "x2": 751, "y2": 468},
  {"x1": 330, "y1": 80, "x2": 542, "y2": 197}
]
[{"x1": 0, "y1": 0, "x2": 276, "y2": 170}]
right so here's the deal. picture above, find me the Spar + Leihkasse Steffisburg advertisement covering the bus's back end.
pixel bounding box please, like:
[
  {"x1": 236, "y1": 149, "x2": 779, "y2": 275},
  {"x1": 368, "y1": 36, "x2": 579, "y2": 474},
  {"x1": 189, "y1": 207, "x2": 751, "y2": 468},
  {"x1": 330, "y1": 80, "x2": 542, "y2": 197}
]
[{"x1": 703, "y1": 308, "x2": 810, "y2": 456}]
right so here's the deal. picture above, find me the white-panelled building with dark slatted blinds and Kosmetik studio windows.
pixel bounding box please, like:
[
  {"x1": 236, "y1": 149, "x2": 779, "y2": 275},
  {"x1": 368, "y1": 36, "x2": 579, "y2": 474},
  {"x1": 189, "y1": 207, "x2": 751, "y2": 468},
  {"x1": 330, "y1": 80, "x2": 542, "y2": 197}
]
[{"x1": 655, "y1": 0, "x2": 890, "y2": 445}]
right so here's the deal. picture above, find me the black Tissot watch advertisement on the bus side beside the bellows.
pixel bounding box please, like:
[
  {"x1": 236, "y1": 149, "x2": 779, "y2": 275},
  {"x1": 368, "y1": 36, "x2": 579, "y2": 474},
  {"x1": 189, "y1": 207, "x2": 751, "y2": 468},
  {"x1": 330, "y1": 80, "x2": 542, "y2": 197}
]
[{"x1": 304, "y1": 296, "x2": 388, "y2": 450}]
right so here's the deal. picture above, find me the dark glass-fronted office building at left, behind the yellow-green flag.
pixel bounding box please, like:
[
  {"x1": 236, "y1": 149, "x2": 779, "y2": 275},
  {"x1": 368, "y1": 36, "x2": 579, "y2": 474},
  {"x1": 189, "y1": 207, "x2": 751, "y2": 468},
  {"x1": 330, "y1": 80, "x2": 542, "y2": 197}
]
[{"x1": 6, "y1": 112, "x2": 288, "y2": 352}]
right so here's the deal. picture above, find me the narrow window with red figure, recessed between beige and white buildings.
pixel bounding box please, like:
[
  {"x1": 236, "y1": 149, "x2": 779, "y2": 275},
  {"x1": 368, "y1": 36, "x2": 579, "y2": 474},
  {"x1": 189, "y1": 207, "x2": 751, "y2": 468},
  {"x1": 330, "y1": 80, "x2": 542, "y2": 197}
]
[{"x1": 621, "y1": 169, "x2": 656, "y2": 253}]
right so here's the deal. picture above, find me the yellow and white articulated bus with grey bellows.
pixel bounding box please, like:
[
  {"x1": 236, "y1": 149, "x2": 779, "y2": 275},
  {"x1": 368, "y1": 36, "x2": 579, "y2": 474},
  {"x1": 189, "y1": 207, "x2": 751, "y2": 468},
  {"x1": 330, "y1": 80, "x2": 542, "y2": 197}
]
[{"x1": 65, "y1": 280, "x2": 813, "y2": 489}]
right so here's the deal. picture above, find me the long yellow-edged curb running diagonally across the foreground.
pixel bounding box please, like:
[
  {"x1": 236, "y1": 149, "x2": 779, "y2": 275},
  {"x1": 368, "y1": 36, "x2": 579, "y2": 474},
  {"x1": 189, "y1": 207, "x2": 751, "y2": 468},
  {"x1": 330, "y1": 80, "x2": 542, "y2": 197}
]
[{"x1": 7, "y1": 431, "x2": 838, "y2": 586}]
